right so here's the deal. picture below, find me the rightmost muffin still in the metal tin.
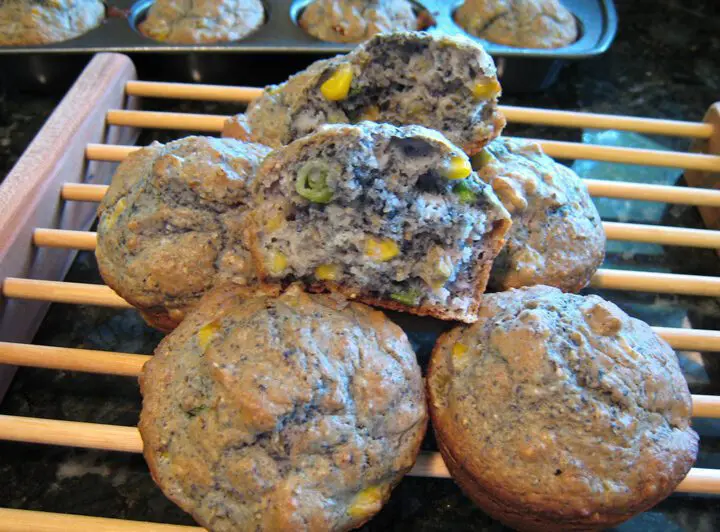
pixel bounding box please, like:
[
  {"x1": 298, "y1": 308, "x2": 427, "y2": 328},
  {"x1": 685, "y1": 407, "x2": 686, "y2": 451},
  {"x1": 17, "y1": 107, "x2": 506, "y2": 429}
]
[{"x1": 455, "y1": 0, "x2": 578, "y2": 48}]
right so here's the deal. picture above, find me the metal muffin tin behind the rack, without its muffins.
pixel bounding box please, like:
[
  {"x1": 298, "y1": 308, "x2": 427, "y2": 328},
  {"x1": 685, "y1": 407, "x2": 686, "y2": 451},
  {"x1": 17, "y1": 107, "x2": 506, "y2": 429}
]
[{"x1": 0, "y1": 0, "x2": 617, "y2": 92}]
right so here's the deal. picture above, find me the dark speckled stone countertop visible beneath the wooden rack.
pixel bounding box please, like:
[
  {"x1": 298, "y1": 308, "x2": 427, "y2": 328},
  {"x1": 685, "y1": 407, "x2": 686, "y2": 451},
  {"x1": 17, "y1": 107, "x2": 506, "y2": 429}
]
[{"x1": 0, "y1": 0, "x2": 720, "y2": 532}]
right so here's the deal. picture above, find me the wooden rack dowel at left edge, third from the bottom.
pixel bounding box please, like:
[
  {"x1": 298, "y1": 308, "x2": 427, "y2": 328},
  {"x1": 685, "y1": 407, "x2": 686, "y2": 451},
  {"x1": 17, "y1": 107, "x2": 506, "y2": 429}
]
[{"x1": 0, "y1": 342, "x2": 150, "y2": 377}]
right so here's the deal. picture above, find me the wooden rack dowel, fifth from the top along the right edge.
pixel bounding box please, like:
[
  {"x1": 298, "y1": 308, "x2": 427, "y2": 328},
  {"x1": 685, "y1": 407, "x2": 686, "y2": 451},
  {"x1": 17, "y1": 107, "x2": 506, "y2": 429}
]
[{"x1": 590, "y1": 269, "x2": 720, "y2": 297}]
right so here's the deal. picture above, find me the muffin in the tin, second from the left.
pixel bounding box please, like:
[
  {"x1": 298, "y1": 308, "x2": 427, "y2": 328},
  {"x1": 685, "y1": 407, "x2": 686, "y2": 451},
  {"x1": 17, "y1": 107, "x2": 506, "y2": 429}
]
[{"x1": 138, "y1": 0, "x2": 265, "y2": 44}]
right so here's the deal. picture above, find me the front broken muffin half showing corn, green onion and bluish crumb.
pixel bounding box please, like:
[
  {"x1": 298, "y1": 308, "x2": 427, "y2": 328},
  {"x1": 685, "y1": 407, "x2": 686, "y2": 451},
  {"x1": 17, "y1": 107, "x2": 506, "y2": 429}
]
[{"x1": 251, "y1": 122, "x2": 510, "y2": 322}]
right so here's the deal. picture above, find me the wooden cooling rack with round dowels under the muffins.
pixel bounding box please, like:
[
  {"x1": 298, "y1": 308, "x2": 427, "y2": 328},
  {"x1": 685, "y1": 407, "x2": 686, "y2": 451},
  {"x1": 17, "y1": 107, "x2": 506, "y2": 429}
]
[{"x1": 0, "y1": 54, "x2": 720, "y2": 532}]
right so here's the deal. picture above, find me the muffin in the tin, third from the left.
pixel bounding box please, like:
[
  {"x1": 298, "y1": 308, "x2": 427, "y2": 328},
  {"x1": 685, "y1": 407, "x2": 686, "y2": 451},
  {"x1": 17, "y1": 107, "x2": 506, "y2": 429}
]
[{"x1": 298, "y1": 0, "x2": 420, "y2": 42}]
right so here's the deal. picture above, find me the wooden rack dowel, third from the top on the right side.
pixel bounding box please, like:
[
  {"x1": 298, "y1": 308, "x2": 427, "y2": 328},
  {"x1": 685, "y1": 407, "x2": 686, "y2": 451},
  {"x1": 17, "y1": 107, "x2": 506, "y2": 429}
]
[{"x1": 583, "y1": 179, "x2": 720, "y2": 207}]
